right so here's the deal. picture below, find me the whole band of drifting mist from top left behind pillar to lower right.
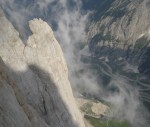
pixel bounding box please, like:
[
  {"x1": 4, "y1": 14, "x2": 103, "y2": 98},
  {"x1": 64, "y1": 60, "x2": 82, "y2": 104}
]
[{"x1": 0, "y1": 0, "x2": 149, "y2": 127}]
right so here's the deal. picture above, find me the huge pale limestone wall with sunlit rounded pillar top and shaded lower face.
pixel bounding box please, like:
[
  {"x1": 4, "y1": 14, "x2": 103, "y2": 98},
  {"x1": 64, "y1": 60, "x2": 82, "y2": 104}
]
[{"x1": 0, "y1": 11, "x2": 85, "y2": 127}]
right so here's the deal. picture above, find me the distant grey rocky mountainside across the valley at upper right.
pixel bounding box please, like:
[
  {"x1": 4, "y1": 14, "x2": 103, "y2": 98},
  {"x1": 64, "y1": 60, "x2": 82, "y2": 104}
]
[{"x1": 87, "y1": 0, "x2": 150, "y2": 63}]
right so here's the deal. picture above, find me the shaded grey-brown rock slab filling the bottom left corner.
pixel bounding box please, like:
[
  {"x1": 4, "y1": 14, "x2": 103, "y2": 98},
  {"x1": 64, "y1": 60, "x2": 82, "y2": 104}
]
[{"x1": 0, "y1": 60, "x2": 32, "y2": 127}]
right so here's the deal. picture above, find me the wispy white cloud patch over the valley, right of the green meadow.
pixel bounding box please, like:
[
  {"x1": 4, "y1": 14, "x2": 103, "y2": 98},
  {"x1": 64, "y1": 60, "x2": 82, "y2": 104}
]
[{"x1": 103, "y1": 74, "x2": 150, "y2": 127}]
